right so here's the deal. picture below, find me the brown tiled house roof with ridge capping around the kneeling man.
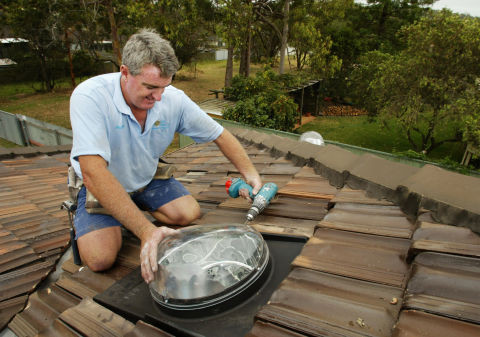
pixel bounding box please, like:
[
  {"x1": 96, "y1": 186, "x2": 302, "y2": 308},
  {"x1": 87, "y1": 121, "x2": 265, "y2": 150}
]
[{"x1": 0, "y1": 128, "x2": 480, "y2": 336}]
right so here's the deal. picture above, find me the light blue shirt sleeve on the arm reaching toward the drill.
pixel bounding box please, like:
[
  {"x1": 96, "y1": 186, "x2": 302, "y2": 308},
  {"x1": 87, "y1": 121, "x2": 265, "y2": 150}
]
[{"x1": 177, "y1": 93, "x2": 223, "y2": 143}]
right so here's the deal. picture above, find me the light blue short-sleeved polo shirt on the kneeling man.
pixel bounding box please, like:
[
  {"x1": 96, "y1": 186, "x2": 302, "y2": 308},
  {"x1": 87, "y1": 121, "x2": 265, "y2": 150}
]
[{"x1": 70, "y1": 73, "x2": 223, "y2": 192}]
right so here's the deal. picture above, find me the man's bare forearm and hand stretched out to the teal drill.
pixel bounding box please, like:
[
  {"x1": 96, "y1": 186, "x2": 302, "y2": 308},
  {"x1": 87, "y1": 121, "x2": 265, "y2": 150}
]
[{"x1": 214, "y1": 129, "x2": 262, "y2": 197}]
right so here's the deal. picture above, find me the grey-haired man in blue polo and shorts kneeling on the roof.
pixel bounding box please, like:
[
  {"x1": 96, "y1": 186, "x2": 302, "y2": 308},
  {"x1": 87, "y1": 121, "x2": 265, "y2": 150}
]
[{"x1": 70, "y1": 29, "x2": 262, "y2": 283}]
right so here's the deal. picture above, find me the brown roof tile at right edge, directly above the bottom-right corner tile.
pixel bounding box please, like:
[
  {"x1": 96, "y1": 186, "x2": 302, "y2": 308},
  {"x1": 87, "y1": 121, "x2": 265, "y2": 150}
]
[{"x1": 404, "y1": 252, "x2": 480, "y2": 324}]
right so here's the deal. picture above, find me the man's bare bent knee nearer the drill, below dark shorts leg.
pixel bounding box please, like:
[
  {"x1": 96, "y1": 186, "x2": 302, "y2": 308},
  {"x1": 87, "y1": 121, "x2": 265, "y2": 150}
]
[{"x1": 151, "y1": 195, "x2": 201, "y2": 226}]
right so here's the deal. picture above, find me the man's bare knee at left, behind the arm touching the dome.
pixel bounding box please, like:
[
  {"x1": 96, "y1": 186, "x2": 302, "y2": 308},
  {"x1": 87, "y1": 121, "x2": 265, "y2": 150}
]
[{"x1": 77, "y1": 226, "x2": 122, "y2": 271}]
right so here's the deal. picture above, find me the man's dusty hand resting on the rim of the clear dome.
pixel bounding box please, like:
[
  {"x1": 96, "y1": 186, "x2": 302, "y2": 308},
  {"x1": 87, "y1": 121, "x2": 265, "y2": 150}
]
[{"x1": 140, "y1": 227, "x2": 178, "y2": 283}]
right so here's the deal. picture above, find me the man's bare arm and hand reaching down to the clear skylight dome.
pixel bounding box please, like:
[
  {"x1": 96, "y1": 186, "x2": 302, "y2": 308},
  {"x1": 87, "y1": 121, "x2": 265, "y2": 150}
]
[{"x1": 78, "y1": 155, "x2": 175, "y2": 283}]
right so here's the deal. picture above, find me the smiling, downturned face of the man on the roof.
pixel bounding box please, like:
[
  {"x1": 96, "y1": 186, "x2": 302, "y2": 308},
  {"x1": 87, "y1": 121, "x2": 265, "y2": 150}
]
[{"x1": 120, "y1": 65, "x2": 172, "y2": 112}]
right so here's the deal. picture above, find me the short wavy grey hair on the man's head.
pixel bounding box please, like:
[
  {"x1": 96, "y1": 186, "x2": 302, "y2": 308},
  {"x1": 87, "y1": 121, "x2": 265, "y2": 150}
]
[{"x1": 122, "y1": 29, "x2": 179, "y2": 77}]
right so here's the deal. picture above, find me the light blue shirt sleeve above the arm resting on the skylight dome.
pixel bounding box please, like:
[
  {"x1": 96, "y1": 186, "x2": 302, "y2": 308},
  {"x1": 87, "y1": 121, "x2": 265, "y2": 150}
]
[{"x1": 70, "y1": 92, "x2": 111, "y2": 167}]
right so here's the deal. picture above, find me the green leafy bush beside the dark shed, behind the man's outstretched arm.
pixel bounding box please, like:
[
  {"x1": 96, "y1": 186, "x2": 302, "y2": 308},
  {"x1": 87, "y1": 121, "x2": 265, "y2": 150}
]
[{"x1": 223, "y1": 67, "x2": 298, "y2": 131}]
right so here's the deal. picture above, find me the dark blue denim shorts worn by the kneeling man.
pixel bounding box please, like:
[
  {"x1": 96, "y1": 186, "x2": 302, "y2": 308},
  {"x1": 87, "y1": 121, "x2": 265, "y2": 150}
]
[{"x1": 74, "y1": 178, "x2": 190, "y2": 239}]
